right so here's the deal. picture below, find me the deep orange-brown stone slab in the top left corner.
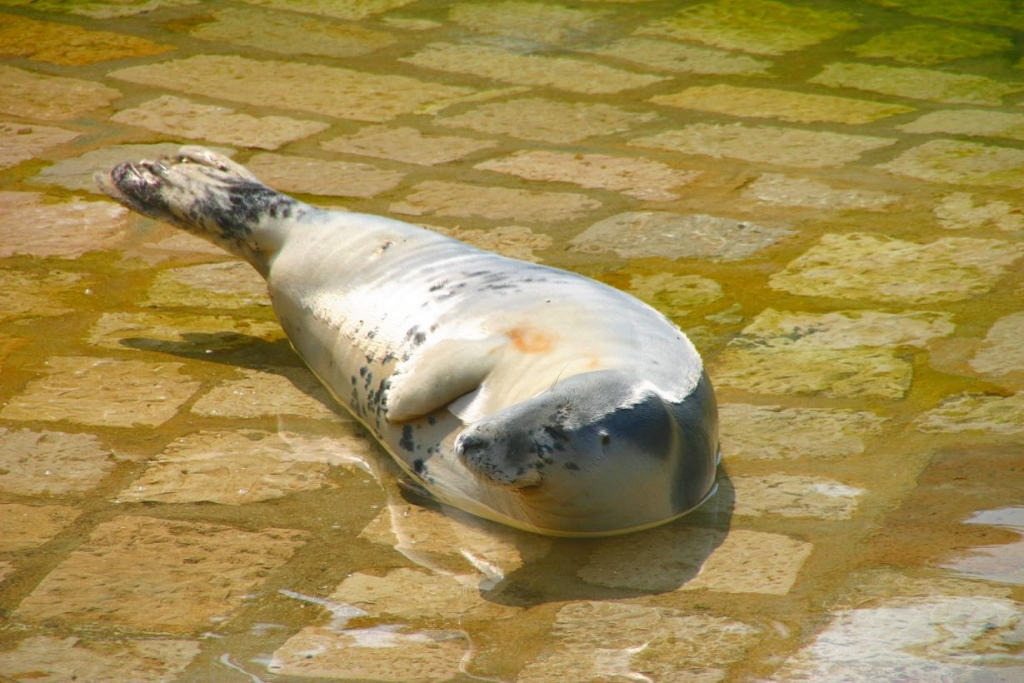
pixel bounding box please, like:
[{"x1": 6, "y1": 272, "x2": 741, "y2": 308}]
[{"x1": 0, "y1": 13, "x2": 174, "y2": 67}]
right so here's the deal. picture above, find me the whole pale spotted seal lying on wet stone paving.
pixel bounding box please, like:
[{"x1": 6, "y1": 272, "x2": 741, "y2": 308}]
[{"x1": 96, "y1": 146, "x2": 719, "y2": 537}]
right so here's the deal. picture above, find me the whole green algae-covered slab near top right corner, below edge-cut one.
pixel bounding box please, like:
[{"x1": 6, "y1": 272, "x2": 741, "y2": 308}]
[{"x1": 850, "y1": 24, "x2": 1014, "y2": 67}]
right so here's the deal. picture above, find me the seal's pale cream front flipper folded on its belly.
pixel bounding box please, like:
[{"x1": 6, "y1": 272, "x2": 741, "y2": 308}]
[{"x1": 387, "y1": 339, "x2": 504, "y2": 423}]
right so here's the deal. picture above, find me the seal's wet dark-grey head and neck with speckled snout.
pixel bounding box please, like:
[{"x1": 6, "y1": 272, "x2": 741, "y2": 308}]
[{"x1": 455, "y1": 371, "x2": 718, "y2": 532}]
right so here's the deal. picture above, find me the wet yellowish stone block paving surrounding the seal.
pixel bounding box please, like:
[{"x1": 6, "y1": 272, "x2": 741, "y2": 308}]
[{"x1": 0, "y1": 0, "x2": 1024, "y2": 682}]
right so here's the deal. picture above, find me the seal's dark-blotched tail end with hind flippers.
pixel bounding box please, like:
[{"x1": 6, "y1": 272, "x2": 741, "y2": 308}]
[{"x1": 95, "y1": 146, "x2": 310, "y2": 275}]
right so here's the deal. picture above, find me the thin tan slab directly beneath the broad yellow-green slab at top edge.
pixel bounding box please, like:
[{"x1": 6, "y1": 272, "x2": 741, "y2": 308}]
[{"x1": 592, "y1": 38, "x2": 772, "y2": 76}]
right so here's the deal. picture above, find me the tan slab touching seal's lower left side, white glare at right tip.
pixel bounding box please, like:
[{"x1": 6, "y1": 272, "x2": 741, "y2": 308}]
[{"x1": 117, "y1": 430, "x2": 367, "y2": 505}]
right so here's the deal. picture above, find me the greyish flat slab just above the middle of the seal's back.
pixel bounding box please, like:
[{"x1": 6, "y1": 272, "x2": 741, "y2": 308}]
[{"x1": 569, "y1": 211, "x2": 793, "y2": 261}]
